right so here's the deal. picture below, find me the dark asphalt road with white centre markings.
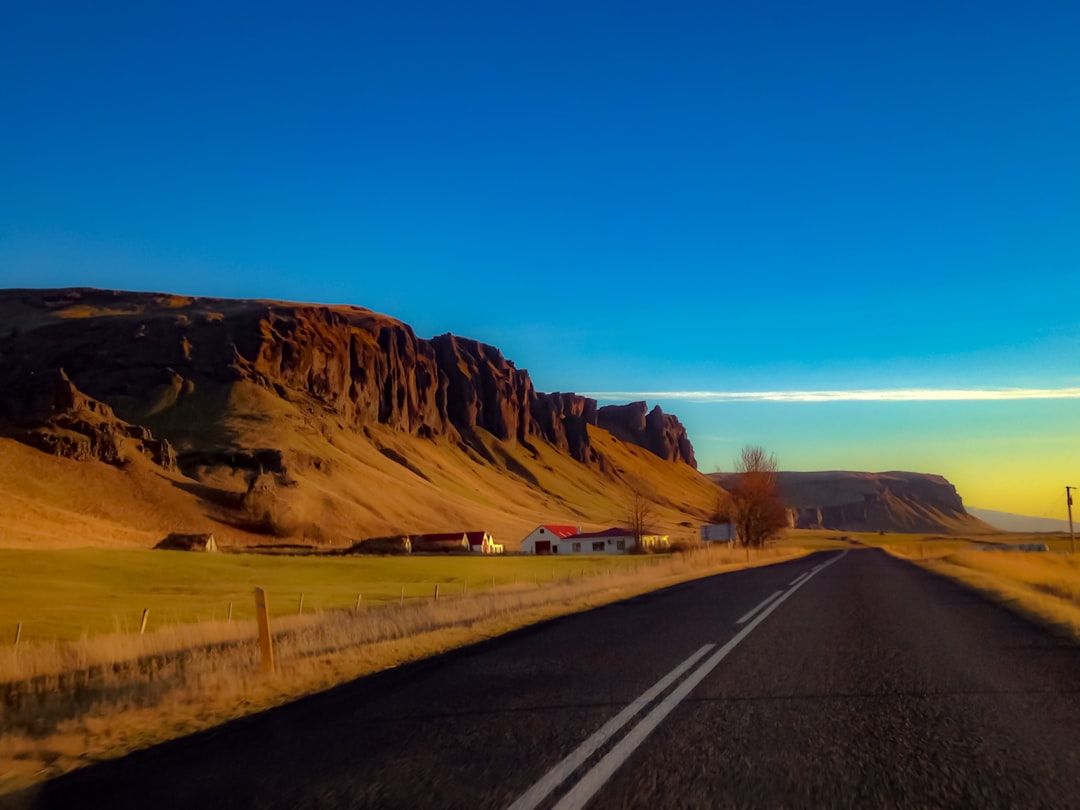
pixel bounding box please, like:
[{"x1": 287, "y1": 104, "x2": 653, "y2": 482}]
[{"x1": 6, "y1": 550, "x2": 1080, "y2": 810}]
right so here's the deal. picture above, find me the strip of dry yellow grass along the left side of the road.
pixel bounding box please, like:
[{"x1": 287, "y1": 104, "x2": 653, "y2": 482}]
[{"x1": 0, "y1": 548, "x2": 805, "y2": 792}]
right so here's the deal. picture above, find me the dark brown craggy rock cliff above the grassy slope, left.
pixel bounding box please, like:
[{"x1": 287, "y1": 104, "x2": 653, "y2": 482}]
[{"x1": 0, "y1": 289, "x2": 694, "y2": 465}]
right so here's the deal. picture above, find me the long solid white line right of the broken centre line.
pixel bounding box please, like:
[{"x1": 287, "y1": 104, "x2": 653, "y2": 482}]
[{"x1": 553, "y1": 550, "x2": 848, "y2": 810}]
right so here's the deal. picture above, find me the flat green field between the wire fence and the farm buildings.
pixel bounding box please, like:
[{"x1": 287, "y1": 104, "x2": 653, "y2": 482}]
[{"x1": 0, "y1": 549, "x2": 661, "y2": 644}]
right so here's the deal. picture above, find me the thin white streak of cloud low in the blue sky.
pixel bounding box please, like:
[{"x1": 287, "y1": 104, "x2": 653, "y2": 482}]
[{"x1": 585, "y1": 388, "x2": 1080, "y2": 403}]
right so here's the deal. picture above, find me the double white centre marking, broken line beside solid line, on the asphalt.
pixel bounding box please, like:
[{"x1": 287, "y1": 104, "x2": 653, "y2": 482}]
[{"x1": 510, "y1": 551, "x2": 848, "y2": 810}]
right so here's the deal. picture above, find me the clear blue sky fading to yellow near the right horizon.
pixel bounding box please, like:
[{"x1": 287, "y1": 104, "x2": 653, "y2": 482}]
[{"x1": 0, "y1": 0, "x2": 1080, "y2": 516}]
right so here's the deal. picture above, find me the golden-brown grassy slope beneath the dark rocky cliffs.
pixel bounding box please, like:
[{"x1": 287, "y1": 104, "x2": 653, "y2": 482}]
[{"x1": 0, "y1": 387, "x2": 715, "y2": 550}]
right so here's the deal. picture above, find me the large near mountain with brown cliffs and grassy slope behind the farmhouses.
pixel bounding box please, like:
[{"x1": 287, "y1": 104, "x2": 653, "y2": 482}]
[{"x1": 0, "y1": 288, "x2": 710, "y2": 548}]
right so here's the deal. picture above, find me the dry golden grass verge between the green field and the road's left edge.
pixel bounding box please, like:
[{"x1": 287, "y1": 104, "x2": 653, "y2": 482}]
[{"x1": 0, "y1": 548, "x2": 806, "y2": 793}]
